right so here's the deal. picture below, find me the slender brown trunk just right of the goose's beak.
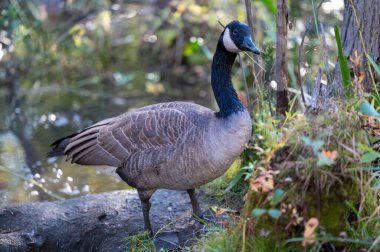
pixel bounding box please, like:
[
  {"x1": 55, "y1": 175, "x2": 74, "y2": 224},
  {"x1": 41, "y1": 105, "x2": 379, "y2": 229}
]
[{"x1": 275, "y1": 0, "x2": 289, "y2": 115}]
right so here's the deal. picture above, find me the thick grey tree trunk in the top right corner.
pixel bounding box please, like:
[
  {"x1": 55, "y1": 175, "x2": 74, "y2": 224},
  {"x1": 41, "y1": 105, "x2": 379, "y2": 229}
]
[{"x1": 328, "y1": 0, "x2": 380, "y2": 96}]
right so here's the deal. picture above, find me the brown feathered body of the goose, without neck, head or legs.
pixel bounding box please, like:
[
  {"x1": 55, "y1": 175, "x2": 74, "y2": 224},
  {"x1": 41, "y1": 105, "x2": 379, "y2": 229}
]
[{"x1": 58, "y1": 102, "x2": 251, "y2": 190}]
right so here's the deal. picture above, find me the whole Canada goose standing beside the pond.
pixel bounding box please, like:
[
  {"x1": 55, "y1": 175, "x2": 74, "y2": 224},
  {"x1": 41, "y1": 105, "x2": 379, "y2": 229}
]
[{"x1": 48, "y1": 21, "x2": 260, "y2": 233}]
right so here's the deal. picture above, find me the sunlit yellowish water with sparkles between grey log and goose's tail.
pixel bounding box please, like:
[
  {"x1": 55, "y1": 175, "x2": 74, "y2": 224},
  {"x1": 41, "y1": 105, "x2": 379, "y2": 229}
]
[{"x1": 0, "y1": 132, "x2": 128, "y2": 205}]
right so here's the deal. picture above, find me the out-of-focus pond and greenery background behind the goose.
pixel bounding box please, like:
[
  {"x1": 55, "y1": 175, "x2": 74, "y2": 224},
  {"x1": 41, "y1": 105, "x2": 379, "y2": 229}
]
[{"x1": 0, "y1": 0, "x2": 344, "y2": 206}]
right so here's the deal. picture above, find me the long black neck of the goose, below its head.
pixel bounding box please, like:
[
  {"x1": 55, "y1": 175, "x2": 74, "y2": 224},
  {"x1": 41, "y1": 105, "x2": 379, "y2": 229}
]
[{"x1": 211, "y1": 37, "x2": 245, "y2": 118}]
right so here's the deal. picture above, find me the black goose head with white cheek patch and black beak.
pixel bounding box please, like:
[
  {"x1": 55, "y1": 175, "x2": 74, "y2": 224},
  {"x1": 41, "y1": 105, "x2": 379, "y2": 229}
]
[{"x1": 222, "y1": 21, "x2": 260, "y2": 54}]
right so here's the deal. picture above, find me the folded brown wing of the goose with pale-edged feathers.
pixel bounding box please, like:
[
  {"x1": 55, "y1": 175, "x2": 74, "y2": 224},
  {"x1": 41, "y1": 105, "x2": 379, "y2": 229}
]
[{"x1": 64, "y1": 103, "x2": 208, "y2": 167}]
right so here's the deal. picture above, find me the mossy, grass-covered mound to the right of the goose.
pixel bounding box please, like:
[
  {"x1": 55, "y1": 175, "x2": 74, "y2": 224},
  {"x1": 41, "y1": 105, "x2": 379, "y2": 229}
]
[{"x1": 237, "y1": 108, "x2": 375, "y2": 248}]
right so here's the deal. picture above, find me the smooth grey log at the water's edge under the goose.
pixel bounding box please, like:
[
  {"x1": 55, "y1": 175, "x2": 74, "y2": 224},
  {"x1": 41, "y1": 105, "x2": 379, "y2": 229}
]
[{"x1": 0, "y1": 190, "x2": 205, "y2": 252}]
